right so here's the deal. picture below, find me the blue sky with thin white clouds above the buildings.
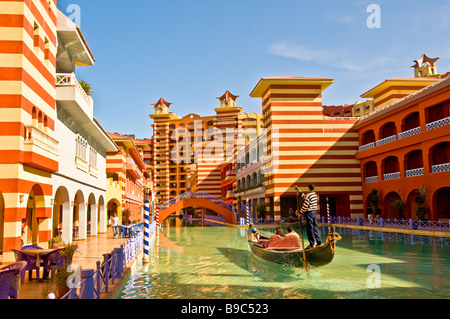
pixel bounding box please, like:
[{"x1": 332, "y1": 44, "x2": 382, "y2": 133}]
[{"x1": 58, "y1": 0, "x2": 450, "y2": 138}]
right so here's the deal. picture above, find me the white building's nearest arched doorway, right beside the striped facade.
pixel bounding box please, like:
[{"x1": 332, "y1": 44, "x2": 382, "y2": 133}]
[{"x1": 52, "y1": 186, "x2": 72, "y2": 243}]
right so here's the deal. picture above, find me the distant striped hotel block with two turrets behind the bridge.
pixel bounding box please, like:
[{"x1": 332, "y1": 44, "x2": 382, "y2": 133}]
[{"x1": 150, "y1": 91, "x2": 261, "y2": 202}]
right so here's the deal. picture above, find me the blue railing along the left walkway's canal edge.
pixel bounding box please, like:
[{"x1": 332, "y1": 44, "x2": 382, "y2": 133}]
[{"x1": 61, "y1": 222, "x2": 156, "y2": 299}]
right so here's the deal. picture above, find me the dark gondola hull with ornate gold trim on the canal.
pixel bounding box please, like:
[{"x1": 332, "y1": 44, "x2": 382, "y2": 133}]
[{"x1": 248, "y1": 227, "x2": 340, "y2": 268}]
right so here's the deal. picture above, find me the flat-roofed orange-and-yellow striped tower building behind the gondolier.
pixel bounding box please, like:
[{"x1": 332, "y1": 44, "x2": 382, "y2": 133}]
[{"x1": 250, "y1": 77, "x2": 363, "y2": 220}]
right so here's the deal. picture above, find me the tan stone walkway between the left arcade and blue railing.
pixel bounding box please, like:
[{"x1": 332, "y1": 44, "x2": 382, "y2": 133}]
[{"x1": 17, "y1": 228, "x2": 127, "y2": 299}]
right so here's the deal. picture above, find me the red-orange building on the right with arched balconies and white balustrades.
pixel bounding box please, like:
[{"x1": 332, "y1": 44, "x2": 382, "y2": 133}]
[{"x1": 355, "y1": 55, "x2": 450, "y2": 220}]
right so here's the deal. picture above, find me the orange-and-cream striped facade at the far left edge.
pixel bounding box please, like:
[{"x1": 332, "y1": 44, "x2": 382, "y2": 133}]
[{"x1": 0, "y1": 0, "x2": 58, "y2": 262}]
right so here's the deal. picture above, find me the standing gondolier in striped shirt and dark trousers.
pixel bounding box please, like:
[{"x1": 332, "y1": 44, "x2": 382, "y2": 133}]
[{"x1": 296, "y1": 184, "x2": 322, "y2": 249}]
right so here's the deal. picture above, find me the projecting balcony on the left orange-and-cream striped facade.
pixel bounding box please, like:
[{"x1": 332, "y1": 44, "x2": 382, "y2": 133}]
[{"x1": 23, "y1": 125, "x2": 59, "y2": 172}]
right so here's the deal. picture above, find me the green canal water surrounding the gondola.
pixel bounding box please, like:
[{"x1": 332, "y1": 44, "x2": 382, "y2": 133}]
[{"x1": 118, "y1": 222, "x2": 450, "y2": 299}]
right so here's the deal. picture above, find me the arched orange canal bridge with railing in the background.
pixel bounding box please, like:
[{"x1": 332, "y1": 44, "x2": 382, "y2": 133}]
[{"x1": 158, "y1": 192, "x2": 236, "y2": 224}]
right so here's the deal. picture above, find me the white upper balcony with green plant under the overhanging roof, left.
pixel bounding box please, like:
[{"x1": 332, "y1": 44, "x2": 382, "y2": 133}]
[{"x1": 56, "y1": 73, "x2": 94, "y2": 122}]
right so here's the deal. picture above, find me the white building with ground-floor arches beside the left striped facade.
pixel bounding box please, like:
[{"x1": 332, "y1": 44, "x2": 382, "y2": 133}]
[{"x1": 51, "y1": 10, "x2": 117, "y2": 242}]
